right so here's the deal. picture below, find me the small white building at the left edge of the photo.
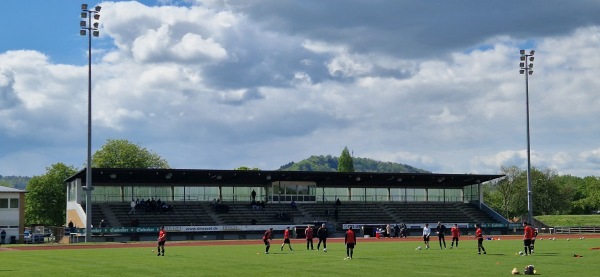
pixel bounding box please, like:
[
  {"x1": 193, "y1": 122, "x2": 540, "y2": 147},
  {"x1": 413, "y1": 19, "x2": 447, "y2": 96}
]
[{"x1": 0, "y1": 186, "x2": 26, "y2": 244}]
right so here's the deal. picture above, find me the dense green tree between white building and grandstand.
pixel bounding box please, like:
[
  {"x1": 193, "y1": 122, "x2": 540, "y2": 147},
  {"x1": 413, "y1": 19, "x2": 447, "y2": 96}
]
[{"x1": 25, "y1": 163, "x2": 77, "y2": 226}]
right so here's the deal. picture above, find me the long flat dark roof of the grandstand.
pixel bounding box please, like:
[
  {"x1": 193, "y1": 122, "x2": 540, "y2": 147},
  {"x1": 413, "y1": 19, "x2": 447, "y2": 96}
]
[{"x1": 65, "y1": 168, "x2": 504, "y2": 188}]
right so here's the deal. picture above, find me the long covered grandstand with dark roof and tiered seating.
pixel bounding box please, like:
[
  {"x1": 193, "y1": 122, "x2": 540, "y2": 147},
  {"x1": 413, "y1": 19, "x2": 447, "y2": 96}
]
[{"x1": 65, "y1": 168, "x2": 509, "y2": 241}]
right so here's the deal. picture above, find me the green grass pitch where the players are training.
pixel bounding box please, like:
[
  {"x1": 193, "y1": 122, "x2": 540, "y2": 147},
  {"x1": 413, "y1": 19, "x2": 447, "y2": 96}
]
[{"x1": 0, "y1": 238, "x2": 600, "y2": 277}]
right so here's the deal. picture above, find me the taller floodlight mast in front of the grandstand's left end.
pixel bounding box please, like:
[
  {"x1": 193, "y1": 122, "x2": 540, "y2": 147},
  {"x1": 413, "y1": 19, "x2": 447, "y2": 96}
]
[{"x1": 79, "y1": 4, "x2": 101, "y2": 242}]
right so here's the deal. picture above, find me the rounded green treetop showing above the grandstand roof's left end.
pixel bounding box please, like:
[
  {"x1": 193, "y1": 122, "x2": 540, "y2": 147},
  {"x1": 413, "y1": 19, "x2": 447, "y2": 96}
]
[{"x1": 92, "y1": 139, "x2": 170, "y2": 168}]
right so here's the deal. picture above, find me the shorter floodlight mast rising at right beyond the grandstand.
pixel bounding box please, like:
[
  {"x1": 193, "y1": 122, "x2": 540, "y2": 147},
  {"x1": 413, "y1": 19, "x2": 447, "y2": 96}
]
[{"x1": 519, "y1": 50, "x2": 535, "y2": 224}]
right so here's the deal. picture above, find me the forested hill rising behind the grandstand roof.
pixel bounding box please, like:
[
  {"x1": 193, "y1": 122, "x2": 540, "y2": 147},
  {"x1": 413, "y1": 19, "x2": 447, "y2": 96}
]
[{"x1": 279, "y1": 155, "x2": 431, "y2": 173}]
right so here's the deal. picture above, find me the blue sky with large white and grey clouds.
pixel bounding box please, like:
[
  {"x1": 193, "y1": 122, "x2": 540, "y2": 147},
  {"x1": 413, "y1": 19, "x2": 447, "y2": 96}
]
[{"x1": 0, "y1": 0, "x2": 600, "y2": 177}]
